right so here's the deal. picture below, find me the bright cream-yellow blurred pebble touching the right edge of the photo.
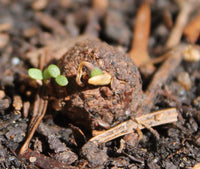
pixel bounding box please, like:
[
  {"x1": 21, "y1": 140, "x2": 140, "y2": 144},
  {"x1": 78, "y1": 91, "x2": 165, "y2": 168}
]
[{"x1": 183, "y1": 45, "x2": 200, "y2": 62}]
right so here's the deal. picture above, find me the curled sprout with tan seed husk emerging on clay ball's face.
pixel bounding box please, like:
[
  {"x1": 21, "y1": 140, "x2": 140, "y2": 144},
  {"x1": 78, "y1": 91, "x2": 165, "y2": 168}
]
[{"x1": 76, "y1": 61, "x2": 111, "y2": 86}]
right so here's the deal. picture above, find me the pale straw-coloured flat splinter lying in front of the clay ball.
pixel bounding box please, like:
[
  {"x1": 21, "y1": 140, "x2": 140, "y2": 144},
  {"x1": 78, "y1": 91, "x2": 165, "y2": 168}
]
[{"x1": 89, "y1": 108, "x2": 178, "y2": 144}]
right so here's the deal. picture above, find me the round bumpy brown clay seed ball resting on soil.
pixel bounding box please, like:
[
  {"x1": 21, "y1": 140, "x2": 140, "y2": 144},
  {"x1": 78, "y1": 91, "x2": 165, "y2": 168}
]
[{"x1": 58, "y1": 39, "x2": 142, "y2": 128}]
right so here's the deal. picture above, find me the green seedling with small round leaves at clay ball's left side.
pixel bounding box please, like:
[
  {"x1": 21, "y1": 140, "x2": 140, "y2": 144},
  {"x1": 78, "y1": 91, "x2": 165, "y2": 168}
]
[{"x1": 28, "y1": 64, "x2": 68, "y2": 86}]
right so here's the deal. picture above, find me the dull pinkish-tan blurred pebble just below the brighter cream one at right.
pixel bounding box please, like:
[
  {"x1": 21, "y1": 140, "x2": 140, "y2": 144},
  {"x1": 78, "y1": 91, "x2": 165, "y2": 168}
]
[{"x1": 177, "y1": 72, "x2": 192, "y2": 91}]
